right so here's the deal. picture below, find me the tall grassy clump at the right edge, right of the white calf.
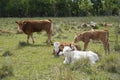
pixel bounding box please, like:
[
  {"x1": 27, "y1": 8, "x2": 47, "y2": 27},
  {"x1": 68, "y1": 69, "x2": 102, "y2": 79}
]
[{"x1": 99, "y1": 54, "x2": 120, "y2": 74}]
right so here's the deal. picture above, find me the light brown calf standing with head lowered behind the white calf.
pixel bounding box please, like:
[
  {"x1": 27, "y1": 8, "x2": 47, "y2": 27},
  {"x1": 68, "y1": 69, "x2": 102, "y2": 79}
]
[{"x1": 74, "y1": 30, "x2": 109, "y2": 53}]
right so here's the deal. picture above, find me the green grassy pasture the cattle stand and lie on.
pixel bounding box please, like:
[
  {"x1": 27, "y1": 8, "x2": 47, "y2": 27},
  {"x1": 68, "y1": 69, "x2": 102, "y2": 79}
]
[{"x1": 0, "y1": 16, "x2": 120, "y2": 80}]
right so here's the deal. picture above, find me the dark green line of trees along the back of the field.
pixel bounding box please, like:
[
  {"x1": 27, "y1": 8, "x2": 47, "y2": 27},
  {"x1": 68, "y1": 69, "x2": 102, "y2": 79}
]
[{"x1": 0, "y1": 0, "x2": 120, "y2": 17}]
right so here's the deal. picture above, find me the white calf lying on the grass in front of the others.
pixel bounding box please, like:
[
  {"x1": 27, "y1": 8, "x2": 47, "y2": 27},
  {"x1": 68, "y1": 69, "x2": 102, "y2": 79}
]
[{"x1": 59, "y1": 46, "x2": 99, "y2": 64}]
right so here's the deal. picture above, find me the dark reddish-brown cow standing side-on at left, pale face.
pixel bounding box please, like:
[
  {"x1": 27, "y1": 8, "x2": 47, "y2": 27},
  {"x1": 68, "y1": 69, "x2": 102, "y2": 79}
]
[{"x1": 16, "y1": 19, "x2": 52, "y2": 43}]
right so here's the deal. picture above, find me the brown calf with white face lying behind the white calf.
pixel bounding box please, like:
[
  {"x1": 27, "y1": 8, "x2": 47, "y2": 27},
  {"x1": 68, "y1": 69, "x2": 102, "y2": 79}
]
[{"x1": 53, "y1": 42, "x2": 81, "y2": 55}]
